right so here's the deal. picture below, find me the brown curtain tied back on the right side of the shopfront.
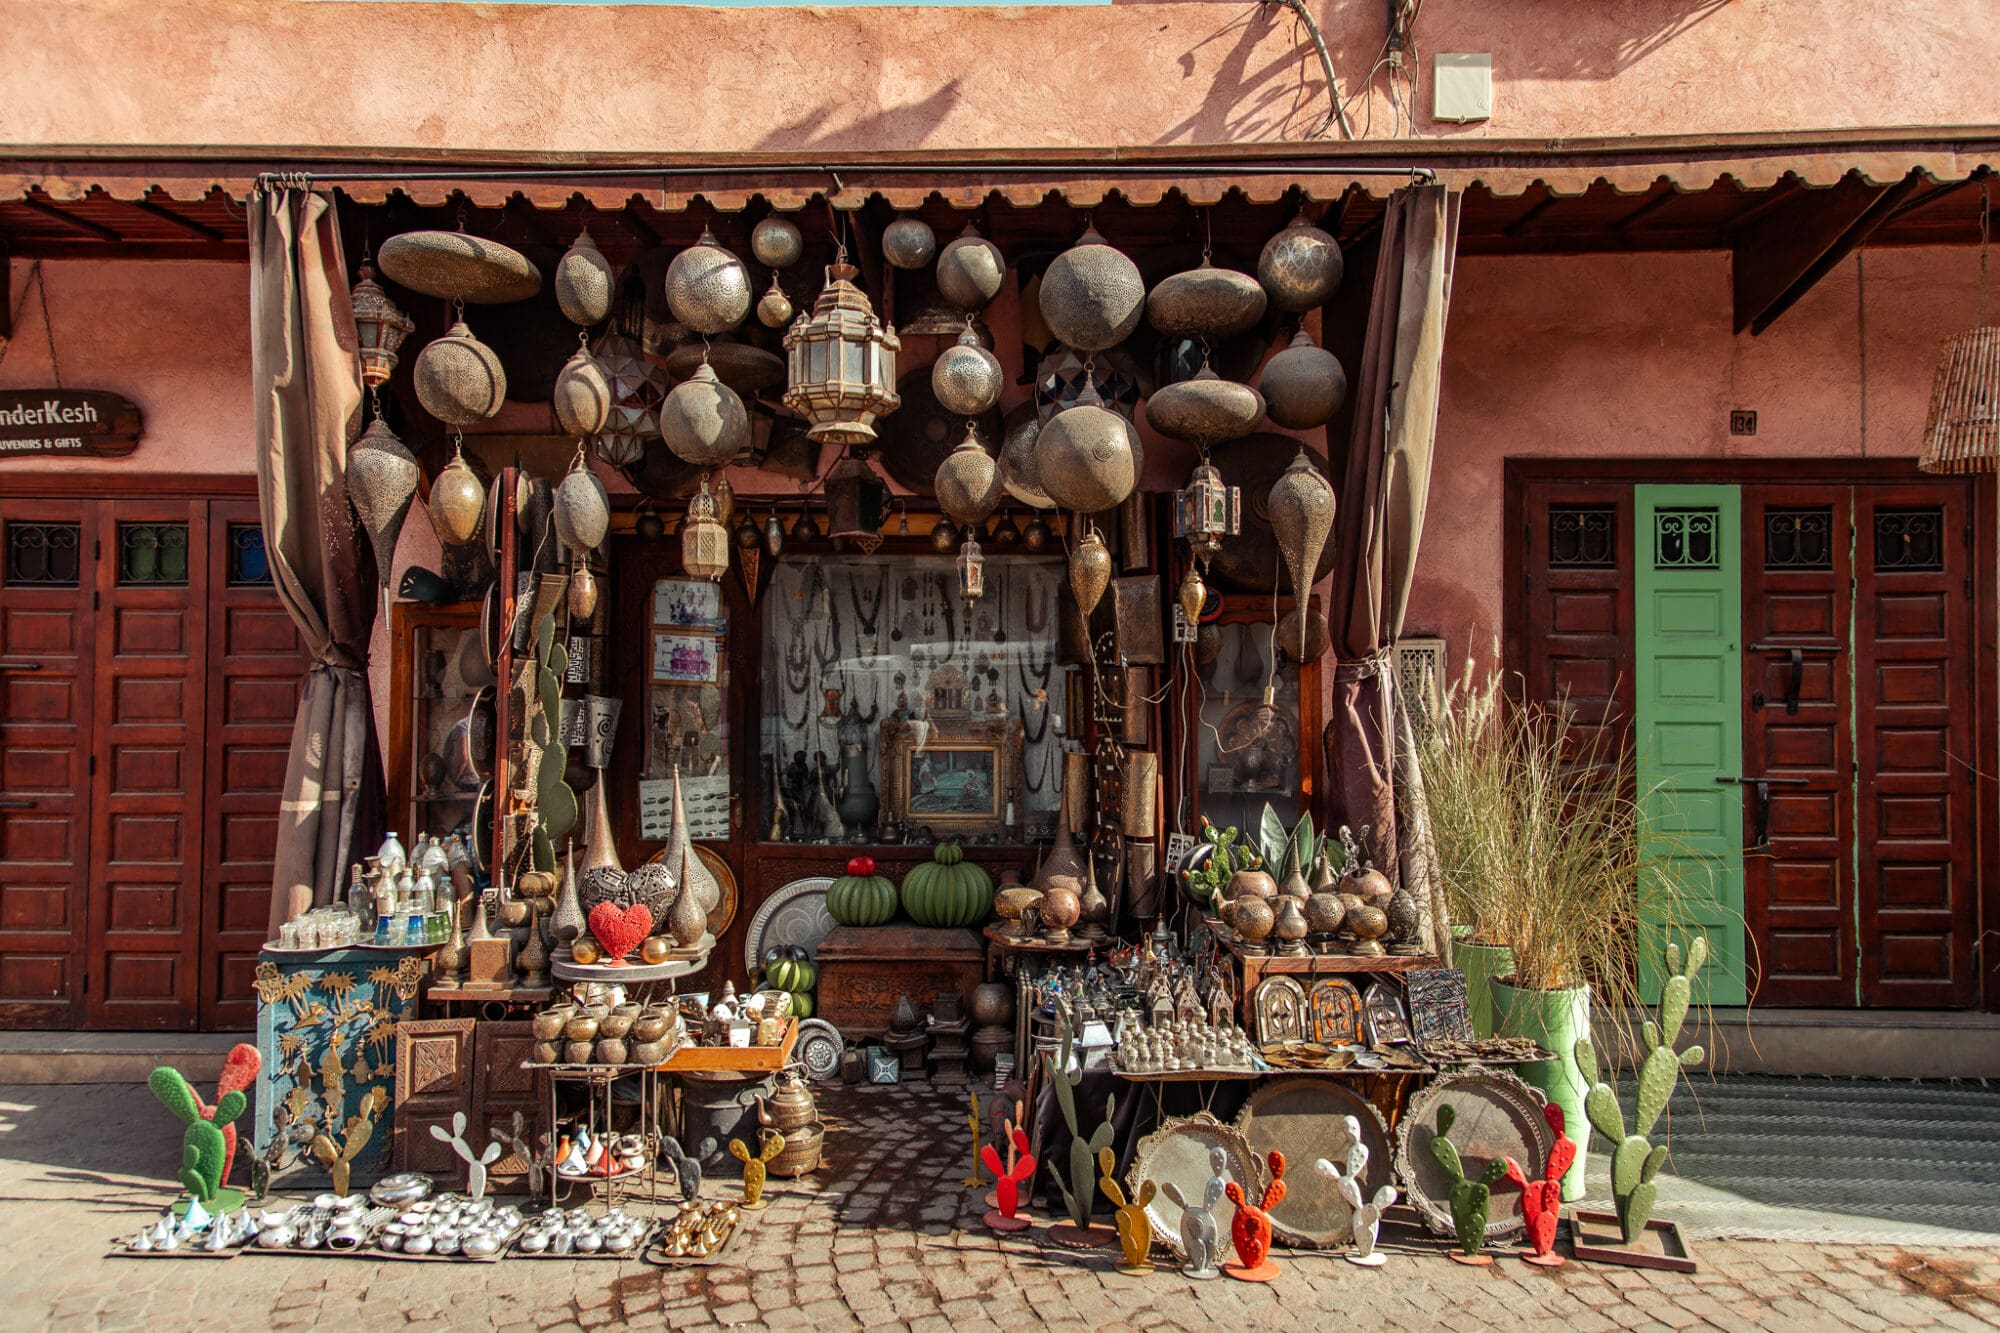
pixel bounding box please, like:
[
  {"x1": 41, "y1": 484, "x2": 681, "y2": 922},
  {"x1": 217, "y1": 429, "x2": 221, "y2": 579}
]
[{"x1": 1324, "y1": 184, "x2": 1460, "y2": 892}]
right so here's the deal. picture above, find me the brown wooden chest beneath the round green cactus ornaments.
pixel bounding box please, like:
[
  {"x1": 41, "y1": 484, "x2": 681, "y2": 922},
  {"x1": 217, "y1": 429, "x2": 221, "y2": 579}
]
[{"x1": 818, "y1": 925, "x2": 986, "y2": 1041}]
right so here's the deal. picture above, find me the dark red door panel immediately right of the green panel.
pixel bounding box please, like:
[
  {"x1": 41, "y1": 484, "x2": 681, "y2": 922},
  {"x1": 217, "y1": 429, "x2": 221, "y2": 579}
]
[{"x1": 1742, "y1": 486, "x2": 1856, "y2": 1005}]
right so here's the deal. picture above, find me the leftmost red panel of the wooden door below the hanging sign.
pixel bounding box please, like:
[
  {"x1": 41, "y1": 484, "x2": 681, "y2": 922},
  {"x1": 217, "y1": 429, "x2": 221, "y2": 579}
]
[{"x1": 0, "y1": 498, "x2": 96, "y2": 1027}]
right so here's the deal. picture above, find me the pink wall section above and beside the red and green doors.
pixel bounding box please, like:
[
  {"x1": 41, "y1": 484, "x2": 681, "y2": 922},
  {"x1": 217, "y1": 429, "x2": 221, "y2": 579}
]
[{"x1": 1406, "y1": 246, "x2": 1978, "y2": 662}]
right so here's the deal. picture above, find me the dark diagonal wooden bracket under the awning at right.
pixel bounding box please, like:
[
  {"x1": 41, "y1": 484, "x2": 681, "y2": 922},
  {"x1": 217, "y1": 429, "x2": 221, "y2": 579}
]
[{"x1": 1730, "y1": 170, "x2": 1922, "y2": 334}]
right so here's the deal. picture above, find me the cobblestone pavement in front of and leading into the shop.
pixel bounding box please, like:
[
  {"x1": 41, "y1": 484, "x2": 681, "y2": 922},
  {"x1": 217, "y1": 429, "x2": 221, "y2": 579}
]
[{"x1": 0, "y1": 1087, "x2": 2000, "y2": 1333}]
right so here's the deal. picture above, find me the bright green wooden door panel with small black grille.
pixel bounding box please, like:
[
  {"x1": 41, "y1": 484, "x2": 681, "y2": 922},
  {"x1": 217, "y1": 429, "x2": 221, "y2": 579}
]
[{"x1": 1632, "y1": 486, "x2": 1746, "y2": 1005}]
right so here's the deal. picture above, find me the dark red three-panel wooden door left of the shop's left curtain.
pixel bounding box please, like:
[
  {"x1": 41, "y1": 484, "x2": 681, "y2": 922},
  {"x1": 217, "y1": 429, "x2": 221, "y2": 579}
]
[{"x1": 0, "y1": 488, "x2": 304, "y2": 1031}]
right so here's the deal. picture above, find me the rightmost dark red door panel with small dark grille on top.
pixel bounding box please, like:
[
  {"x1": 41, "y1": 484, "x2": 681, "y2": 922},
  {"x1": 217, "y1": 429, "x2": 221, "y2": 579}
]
[{"x1": 1854, "y1": 486, "x2": 1978, "y2": 1007}]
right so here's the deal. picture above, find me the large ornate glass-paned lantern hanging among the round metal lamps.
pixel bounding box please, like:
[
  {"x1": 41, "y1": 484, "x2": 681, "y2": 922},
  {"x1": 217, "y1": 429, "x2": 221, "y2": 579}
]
[{"x1": 784, "y1": 252, "x2": 902, "y2": 444}]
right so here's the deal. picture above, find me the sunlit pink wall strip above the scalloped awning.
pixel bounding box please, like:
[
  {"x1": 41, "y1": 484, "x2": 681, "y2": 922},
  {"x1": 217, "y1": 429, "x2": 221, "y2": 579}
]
[{"x1": 0, "y1": 0, "x2": 2000, "y2": 152}]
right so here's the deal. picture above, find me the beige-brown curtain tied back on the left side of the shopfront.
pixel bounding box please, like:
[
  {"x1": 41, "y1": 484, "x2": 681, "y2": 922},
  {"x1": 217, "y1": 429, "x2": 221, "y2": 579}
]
[{"x1": 250, "y1": 188, "x2": 382, "y2": 937}]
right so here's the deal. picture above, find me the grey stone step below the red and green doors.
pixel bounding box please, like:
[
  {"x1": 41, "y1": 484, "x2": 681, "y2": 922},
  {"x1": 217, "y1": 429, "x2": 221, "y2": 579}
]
[{"x1": 1626, "y1": 1007, "x2": 2000, "y2": 1079}]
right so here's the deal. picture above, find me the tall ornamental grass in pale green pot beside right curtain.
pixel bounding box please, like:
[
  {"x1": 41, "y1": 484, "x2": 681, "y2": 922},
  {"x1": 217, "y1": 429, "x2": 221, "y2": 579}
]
[{"x1": 1416, "y1": 664, "x2": 1700, "y2": 1199}]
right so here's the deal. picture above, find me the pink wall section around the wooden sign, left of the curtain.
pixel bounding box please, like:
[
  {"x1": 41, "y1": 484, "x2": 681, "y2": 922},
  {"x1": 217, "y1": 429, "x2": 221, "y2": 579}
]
[{"x1": 0, "y1": 260, "x2": 256, "y2": 472}]
